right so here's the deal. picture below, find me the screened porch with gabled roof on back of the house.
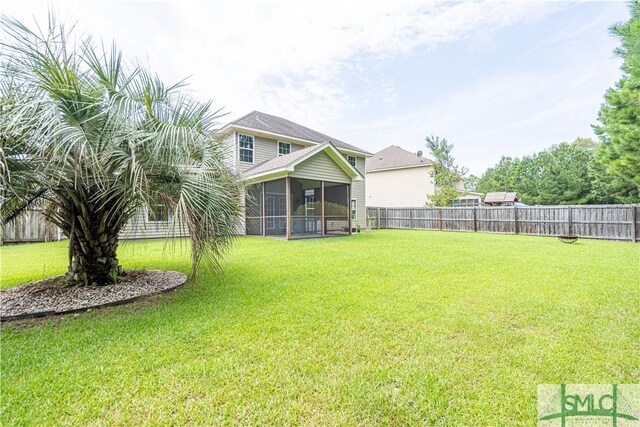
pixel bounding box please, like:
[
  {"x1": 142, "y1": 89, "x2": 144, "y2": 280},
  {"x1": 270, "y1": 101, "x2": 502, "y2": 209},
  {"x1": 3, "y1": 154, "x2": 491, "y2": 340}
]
[{"x1": 245, "y1": 144, "x2": 362, "y2": 239}]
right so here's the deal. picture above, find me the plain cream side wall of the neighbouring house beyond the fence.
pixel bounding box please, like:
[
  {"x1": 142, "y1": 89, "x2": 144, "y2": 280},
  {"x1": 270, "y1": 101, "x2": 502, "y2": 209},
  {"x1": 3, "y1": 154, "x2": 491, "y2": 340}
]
[{"x1": 366, "y1": 166, "x2": 435, "y2": 208}]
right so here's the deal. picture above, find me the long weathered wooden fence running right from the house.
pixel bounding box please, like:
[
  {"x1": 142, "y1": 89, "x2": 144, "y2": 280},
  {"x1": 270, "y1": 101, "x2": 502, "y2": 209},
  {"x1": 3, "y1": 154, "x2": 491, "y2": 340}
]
[{"x1": 367, "y1": 205, "x2": 640, "y2": 242}]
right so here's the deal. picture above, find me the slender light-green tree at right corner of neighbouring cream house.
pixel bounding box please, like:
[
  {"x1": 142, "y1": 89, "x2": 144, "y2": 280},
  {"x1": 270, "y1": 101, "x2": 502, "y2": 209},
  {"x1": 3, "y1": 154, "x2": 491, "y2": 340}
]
[{"x1": 426, "y1": 135, "x2": 467, "y2": 206}]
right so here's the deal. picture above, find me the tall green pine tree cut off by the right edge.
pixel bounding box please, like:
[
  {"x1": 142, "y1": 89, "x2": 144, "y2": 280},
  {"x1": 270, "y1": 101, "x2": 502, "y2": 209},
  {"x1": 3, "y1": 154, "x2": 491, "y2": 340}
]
[{"x1": 594, "y1": 0, "x2": 640, "y2": 202}]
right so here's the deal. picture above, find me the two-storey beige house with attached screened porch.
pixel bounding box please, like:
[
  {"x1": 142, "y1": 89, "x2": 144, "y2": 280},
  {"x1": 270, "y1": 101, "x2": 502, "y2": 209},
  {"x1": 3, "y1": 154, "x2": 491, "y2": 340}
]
[{"x1": 220, "y1": 111, "x2": 371, "y2": 239}]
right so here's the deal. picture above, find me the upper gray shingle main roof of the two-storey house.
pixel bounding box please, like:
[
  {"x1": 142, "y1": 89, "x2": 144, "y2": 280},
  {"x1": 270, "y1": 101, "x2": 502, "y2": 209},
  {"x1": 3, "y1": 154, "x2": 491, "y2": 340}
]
[{"x1": 229, "y1": 111, "x2": 371, "y2": 155}]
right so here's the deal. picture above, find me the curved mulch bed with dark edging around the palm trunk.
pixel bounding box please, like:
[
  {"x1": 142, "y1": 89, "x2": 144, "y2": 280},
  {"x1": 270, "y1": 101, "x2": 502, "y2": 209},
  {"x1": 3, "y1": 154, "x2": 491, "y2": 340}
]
[{"x1": 0, "y1": 270, "x2": 187, "y2": 321}]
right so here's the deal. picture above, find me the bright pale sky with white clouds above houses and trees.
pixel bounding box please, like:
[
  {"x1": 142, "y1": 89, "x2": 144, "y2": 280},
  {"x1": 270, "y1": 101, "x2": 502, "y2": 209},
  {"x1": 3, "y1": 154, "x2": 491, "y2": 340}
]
[{"x1": 0, "y1": 0, "x2": 629, "y2": 175}]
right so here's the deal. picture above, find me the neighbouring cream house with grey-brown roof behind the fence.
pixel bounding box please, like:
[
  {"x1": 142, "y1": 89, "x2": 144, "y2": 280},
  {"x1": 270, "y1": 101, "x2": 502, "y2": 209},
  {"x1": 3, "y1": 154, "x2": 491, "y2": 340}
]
[{"x1": 365, "y1": 145, "x2": 464, "y2": 208}]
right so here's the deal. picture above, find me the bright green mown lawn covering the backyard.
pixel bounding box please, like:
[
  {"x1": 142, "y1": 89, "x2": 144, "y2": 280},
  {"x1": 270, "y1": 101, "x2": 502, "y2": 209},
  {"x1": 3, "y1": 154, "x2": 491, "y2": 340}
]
[{"x1": 0, "y1": 230, "x2": 640, "y2": 425}]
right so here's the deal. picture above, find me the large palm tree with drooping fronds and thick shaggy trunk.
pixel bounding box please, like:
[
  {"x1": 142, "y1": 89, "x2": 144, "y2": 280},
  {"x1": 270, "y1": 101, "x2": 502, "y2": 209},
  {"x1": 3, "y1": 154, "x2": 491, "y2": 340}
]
[{"x1": 0, "y1": 17, "x2": 240, "y2": 284}]
